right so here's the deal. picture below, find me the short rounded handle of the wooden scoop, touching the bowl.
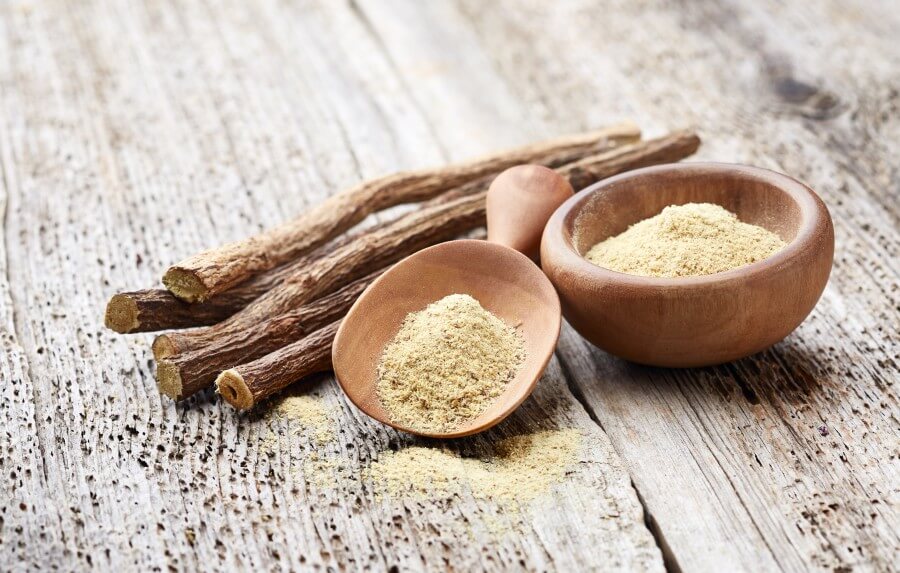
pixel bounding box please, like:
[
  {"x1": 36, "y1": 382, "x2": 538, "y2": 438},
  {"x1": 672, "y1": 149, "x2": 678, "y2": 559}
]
[{"x1": 487, "y1": 165, "x2": 574, "y2": 261}]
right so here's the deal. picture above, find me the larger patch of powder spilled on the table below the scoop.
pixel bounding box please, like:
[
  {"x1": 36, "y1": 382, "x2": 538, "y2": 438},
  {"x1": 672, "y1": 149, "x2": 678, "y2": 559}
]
[{"x1": 365, "y1": 429, "x2": 581, "y2": 507}]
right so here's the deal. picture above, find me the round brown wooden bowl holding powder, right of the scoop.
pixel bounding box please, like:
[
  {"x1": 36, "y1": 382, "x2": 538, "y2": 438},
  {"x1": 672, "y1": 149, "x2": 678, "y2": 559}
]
[{"x1": 541, "y1": 163, "x2": 834, "y2": 367}]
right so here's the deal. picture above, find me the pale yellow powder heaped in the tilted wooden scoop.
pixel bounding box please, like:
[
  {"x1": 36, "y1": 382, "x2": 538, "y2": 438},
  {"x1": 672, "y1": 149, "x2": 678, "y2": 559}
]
[{"x1": 377, "y1": 294, "x2": 525, "y2": 432}]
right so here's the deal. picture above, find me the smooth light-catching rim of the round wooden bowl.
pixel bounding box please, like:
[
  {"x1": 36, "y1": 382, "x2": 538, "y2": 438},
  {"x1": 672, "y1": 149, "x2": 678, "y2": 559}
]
[{"x1": 546, "y1": 161, "x2": 830, "y2": 288}]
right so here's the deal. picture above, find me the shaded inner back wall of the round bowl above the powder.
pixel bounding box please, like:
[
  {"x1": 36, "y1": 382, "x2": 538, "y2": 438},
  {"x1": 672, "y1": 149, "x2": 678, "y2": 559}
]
[{"x1": 564, "y1": 164, "x2": 803, "y2": 255}]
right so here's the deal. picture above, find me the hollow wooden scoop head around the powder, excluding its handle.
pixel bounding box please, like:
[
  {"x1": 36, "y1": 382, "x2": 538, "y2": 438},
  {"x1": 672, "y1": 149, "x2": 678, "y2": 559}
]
[{"x1": 333, "y1": 240, "x2": 561, "y2": 437}]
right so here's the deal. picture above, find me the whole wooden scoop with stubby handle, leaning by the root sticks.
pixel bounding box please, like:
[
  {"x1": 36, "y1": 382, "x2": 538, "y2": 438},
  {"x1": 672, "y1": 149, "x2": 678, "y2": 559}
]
[{"x1": 332, "y1": 165, "x2": 573, "y2": 438}]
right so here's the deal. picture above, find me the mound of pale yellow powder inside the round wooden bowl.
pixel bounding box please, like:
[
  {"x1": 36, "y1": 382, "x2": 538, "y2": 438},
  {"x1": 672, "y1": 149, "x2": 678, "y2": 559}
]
[{"x1": 585, "y1": 203, "x2": 785, "y2": 277}]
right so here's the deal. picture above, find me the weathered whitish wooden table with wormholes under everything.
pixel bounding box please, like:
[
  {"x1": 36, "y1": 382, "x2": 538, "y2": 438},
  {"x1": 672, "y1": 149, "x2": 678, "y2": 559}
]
[{"x1": 0, "y1": 0, "x2": 900, "y2": 571}]
